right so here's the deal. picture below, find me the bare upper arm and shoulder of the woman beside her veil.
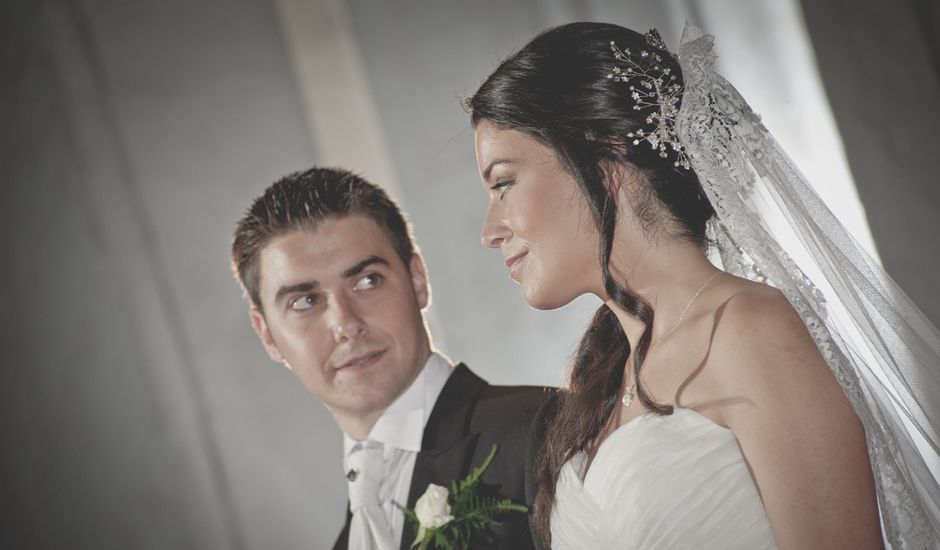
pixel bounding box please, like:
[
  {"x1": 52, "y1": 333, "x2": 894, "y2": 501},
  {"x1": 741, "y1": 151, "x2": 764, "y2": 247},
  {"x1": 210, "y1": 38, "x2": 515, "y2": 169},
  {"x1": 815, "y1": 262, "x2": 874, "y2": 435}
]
[{"x1": 703, "y1": 284, "x2": 880, "y2": 548}]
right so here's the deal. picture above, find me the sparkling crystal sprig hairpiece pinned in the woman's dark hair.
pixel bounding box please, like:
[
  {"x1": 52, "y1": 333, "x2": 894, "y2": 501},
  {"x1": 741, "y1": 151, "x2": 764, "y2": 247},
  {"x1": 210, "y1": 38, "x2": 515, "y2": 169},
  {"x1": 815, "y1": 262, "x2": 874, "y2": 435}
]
[{"x1": 607, "y1": 29, "x2": 690, "y2": 169}]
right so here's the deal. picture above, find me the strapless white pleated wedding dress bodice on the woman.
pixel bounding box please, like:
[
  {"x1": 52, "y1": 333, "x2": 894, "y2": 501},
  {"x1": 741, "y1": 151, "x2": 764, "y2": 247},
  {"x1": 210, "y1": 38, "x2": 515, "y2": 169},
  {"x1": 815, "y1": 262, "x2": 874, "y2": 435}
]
[{"x1": 551, "y1": 408, "x2": 777, "y2": 550}]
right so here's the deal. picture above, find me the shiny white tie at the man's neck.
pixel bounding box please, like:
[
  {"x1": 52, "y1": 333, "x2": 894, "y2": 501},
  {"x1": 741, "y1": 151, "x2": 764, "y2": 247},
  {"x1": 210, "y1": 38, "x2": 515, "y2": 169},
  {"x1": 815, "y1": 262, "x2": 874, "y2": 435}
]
[{"x1": 347, "y1": 441, "x2": 398, "y2": 550}]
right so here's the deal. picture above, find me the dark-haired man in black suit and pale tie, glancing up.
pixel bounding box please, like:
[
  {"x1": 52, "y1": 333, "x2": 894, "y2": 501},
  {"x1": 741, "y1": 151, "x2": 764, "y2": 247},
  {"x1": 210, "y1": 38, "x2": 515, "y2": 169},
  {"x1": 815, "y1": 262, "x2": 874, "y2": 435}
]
[{"x1": 232, "y1": 168, "x2": 550, "y2": 550}]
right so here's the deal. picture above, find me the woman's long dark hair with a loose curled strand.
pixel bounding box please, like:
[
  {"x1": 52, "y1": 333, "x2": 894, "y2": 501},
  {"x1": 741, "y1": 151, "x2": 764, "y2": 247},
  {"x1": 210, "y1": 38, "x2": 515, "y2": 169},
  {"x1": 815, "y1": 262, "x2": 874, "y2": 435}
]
[{"x1": 466, "y1": 23, "x2": 714, "y2": 542}]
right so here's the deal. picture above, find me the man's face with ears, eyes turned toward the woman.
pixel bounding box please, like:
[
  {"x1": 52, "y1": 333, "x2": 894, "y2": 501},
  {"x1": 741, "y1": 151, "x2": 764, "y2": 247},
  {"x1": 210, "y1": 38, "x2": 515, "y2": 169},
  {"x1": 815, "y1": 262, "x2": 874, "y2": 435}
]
[{"x1": 251, "y1": 215, "x2": 430, "y2": 417}]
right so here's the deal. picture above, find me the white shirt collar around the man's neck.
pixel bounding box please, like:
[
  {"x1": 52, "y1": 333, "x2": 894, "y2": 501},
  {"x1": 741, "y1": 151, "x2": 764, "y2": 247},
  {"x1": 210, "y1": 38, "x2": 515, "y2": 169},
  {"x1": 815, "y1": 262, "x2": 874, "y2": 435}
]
[{"x1": 343, "y1": 352, "x2": 454, "y2": 457}]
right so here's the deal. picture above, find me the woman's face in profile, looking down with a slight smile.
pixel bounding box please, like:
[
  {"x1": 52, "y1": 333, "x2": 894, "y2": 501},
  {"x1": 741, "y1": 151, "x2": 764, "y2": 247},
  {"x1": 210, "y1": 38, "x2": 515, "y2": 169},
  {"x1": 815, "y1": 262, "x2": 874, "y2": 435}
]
[{"x1": 476, "y1": 121, "x2": 602, "y2": 309}]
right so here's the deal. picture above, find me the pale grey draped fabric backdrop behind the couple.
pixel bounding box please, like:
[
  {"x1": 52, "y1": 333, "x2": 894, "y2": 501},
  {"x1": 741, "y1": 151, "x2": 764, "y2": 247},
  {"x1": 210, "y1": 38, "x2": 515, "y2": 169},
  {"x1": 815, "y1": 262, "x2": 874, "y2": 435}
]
[{"x1": 0, "y1": 0, "x2": 940, "y2": 549}]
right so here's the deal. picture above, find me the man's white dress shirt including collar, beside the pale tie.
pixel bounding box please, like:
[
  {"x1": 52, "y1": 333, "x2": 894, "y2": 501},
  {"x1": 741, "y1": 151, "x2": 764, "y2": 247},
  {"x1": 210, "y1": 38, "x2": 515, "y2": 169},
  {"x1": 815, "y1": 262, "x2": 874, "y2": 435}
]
[{"x1": 343, "y1": 352, "x2": 454, "y2": 550}]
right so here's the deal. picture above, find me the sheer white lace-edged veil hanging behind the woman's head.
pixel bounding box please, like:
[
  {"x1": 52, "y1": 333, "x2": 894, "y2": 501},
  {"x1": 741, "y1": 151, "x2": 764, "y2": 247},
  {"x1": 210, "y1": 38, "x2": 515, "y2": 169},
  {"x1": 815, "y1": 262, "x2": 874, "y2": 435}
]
[{"x1": 676, "y1": 26, "x2": 940, "y2": 548}]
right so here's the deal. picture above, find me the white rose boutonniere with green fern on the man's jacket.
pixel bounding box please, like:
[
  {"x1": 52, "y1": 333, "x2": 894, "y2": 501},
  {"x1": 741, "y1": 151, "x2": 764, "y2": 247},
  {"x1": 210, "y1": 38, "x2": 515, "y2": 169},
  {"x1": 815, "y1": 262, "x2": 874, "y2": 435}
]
[{"x1": 398, "y1": 445, "x2": 529, "y2": 550}]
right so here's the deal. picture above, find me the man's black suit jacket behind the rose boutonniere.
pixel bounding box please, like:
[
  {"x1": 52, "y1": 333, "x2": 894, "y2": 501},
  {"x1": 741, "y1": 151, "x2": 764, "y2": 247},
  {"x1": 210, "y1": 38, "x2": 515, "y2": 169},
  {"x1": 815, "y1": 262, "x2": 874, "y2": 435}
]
[{"x1": 333, "y1": 364, "x2": 554, "y2": 550}]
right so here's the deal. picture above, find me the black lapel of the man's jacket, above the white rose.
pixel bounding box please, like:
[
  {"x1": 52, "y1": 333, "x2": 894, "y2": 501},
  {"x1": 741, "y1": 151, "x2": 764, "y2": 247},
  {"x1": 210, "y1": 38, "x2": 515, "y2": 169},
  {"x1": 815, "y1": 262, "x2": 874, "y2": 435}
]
[{"x1": 401, "y1": 364, "x2": 487, "y2": 550}]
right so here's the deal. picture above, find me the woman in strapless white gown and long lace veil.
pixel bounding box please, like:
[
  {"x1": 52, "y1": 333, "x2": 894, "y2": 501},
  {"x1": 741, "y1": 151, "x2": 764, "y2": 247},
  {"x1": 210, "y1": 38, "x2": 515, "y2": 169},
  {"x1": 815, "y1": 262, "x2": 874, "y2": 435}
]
[{"x1": 467, "y1": 23, "x2": 940, "y2": 549}]
